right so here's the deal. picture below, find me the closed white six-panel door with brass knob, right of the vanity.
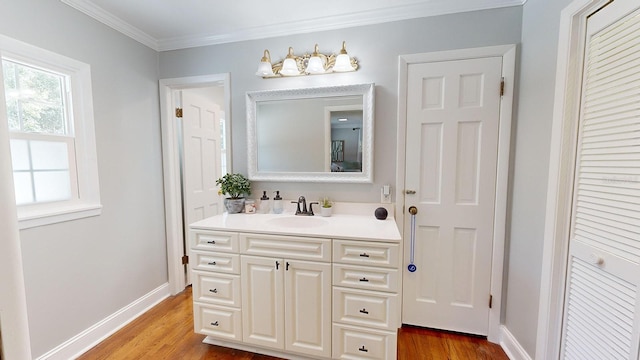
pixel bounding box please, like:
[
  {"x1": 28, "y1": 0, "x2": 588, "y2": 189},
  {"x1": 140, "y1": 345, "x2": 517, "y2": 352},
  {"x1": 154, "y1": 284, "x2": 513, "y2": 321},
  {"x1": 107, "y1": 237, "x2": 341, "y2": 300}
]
[{"x1": 402, "y1": 57, "x2": 502, "y2": 335}]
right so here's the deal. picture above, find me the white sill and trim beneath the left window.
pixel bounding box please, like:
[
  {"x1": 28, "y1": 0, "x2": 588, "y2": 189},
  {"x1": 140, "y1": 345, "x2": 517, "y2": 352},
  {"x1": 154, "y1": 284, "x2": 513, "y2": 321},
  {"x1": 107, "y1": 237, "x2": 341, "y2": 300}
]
[{"x1": 18, "y1": 203, "x2": 102, "y2": 230}]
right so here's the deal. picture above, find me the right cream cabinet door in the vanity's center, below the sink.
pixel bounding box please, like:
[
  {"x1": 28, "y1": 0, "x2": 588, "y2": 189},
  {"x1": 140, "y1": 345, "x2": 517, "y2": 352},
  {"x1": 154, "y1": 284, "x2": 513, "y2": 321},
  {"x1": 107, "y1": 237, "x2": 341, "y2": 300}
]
[{"x1": 284, "y1": 260, "x2": 331, "y2": 357}]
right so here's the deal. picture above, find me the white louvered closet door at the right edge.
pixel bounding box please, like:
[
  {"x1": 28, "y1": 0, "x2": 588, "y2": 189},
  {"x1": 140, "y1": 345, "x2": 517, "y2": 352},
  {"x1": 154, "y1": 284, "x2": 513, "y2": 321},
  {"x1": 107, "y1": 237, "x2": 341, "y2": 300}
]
[{"x1": 561, "y1": 0, "x2": 640, "y2": 360}]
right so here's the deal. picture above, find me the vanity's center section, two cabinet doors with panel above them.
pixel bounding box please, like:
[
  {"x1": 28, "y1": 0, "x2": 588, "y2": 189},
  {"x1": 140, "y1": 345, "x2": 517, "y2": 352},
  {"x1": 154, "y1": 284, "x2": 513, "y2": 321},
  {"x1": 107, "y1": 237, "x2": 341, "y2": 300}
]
[{"x1": 240, "y1": 234, "x2": 331, "y2": 358}]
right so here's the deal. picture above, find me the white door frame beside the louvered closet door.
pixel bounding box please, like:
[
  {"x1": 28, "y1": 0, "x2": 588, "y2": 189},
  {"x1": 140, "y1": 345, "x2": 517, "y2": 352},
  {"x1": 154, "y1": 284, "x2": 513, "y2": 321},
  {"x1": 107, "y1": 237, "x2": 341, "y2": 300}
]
[{"x1": 535, "y1": 0, "x2": 610, "y2": 360}]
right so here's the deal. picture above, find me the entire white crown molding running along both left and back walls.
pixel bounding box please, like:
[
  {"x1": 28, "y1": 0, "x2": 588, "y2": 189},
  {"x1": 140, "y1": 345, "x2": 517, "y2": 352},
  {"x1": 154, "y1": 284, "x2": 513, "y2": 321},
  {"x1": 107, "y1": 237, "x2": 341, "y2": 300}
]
[{"x1": 60, "y1": 0, "x2": 527, "y2": 51}]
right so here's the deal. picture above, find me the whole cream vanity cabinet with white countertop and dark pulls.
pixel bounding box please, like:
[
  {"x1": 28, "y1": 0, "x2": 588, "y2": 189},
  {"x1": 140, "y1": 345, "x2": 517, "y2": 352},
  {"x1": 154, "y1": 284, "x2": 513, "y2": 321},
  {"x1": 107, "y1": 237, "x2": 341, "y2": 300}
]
[{"x1": 190, "y1": 214, "x2": 401, "y2": 359}]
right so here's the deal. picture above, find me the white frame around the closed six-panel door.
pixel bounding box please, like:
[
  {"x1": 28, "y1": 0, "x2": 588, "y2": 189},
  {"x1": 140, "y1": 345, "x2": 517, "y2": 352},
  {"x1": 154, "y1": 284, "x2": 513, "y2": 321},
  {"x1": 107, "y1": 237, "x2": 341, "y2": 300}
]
[{"x1": 395, "y1": 44, "x2": 516, "y2": 343}]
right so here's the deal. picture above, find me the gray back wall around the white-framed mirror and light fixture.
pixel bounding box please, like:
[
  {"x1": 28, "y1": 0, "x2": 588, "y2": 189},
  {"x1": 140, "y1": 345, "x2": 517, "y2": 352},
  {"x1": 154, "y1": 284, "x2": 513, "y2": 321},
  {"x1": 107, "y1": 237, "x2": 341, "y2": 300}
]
[{"x1": 160, "y1": 7, "x2": 521, "y2": 202}]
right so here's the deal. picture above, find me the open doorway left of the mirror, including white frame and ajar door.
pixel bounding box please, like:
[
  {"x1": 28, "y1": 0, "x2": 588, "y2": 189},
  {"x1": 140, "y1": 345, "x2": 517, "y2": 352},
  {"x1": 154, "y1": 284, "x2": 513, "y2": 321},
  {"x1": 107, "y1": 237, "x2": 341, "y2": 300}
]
[{"x1": 160, "y1": 74, "x2": 231, "y2": 294}]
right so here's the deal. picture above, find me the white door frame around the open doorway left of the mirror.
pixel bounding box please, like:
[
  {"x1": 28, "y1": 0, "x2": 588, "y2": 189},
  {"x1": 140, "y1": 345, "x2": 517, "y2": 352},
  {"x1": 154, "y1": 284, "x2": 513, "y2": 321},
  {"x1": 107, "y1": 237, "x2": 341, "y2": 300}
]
[{"x1": 159, "y1": 73, "x2": 231, "y2": 295}]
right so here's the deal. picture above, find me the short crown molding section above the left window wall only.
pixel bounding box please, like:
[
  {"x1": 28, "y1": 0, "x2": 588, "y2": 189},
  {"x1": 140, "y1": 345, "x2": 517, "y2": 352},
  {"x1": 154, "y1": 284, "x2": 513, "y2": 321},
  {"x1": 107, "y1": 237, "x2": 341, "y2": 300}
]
[{"x1": 60, "y1": 0, "x2": 160, "y2": 51}]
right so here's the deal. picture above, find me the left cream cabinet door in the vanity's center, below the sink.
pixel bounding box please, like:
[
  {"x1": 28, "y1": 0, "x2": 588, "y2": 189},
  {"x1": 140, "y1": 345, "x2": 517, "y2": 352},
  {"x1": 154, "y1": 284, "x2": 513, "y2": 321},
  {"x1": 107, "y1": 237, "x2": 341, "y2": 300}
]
[{"x1": 240, "y1": 255, "x2": 284, "y2": 349}]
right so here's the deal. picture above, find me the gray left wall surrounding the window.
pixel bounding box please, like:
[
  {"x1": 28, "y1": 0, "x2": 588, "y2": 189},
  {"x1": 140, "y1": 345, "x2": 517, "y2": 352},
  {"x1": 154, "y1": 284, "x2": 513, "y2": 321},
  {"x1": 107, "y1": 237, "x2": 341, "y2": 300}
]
[{"x1": 0, "y1": 0, "x2": 167, "y2": 357}]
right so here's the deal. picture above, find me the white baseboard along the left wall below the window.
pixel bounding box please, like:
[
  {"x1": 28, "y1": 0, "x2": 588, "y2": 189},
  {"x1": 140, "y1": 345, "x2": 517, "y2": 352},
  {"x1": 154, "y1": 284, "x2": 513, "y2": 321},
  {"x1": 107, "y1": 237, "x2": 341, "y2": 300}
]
[{"x1": 37, "y1": 283, "x2": 170, "y2": 360}]
